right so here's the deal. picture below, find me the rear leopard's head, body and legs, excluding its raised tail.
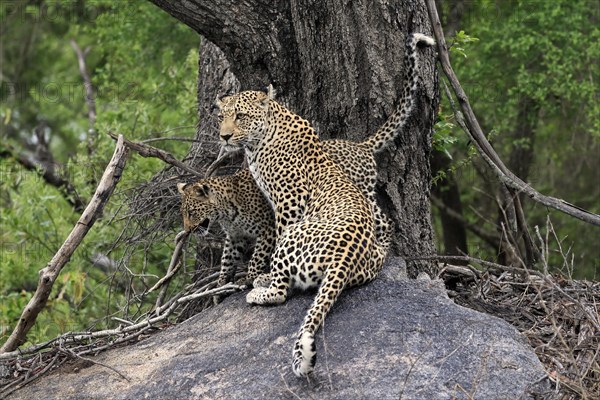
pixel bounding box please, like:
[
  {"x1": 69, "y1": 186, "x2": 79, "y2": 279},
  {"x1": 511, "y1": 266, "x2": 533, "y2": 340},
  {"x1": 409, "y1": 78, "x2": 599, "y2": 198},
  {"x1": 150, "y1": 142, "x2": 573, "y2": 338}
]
[{"x1": 177, "y1": 140, "x2": 391, "y2": 286}]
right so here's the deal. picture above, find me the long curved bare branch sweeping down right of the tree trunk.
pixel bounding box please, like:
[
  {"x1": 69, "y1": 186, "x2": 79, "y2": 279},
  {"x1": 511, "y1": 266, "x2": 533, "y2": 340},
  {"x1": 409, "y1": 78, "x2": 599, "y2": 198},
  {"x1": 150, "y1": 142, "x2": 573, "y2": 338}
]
[{"x1": 426, "y1": 0, "x2": 600, "y2": 226}]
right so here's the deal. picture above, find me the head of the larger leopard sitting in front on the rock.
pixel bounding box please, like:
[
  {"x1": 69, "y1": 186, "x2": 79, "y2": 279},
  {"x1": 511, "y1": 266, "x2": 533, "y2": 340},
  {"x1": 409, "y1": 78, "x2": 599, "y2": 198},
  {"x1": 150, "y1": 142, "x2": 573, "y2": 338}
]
[{"x1": 216, "y1": 91, "x2": 271, "y2": 151}]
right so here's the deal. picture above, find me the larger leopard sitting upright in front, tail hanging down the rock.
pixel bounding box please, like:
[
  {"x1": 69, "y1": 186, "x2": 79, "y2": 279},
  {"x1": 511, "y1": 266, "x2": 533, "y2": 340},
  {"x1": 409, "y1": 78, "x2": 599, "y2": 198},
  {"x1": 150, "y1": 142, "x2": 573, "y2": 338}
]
[{"x1": 217, "y1": 34, "x2": 431, "y2": 376}]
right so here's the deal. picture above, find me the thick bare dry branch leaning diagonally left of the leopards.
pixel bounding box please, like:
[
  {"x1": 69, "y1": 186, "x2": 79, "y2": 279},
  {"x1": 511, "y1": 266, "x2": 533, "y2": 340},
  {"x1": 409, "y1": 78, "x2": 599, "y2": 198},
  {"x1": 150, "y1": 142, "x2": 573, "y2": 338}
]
[{"x1": 0, "y1": 136, "x2": 128, "y2": 353}]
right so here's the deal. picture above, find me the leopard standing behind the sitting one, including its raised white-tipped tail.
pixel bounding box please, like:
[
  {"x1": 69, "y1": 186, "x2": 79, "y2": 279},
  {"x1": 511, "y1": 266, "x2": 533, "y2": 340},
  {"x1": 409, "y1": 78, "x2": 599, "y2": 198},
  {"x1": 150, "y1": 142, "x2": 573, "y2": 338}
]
[{"x1": 178, "y1": 34, "x2": 433, "y2": 296}]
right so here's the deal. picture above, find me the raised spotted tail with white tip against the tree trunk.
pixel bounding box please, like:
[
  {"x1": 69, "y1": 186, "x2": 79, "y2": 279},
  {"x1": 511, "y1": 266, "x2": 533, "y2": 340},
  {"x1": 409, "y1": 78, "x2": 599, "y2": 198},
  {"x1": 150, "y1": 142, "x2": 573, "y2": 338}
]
[{"x1": 362, "y1": 33, "x2": 435, "y2": 154}]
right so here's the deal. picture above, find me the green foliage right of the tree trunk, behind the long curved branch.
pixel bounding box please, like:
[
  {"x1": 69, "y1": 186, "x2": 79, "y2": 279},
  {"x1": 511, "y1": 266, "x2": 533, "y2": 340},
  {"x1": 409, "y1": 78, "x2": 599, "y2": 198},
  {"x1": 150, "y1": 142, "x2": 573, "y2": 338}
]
[{"x1": 436, "y1": 0, "x2": 600, "y2": 278}]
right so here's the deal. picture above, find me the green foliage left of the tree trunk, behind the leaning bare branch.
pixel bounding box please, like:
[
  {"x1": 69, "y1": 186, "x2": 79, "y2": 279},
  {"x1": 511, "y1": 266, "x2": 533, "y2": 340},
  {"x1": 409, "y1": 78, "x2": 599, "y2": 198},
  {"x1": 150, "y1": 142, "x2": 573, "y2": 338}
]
[{"x1": 0, "y1": 0, "x2": 199, "y2": 344}]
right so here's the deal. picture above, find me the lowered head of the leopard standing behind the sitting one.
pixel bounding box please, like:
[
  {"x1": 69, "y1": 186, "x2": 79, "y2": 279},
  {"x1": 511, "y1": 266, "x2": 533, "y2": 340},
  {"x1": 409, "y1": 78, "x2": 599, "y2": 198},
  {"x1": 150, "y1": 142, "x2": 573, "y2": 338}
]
[{"x1": 177, "y1": 179, "x2": 229, "y2": 232}]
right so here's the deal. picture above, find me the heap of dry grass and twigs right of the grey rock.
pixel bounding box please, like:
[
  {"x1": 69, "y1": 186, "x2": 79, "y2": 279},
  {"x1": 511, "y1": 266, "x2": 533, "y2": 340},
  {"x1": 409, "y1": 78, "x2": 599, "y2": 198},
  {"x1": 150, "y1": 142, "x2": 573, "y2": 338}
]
[{"x1": 442, "y1": 267, "x2": 600, "y2": 399}]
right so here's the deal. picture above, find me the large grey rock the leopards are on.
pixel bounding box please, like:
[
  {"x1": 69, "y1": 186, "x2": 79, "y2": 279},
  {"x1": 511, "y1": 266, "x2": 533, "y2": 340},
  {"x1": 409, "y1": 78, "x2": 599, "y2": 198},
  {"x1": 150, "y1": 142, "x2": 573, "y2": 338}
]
[{"x1": 11, "y1": 259, "x2": 548, "y2": 400}]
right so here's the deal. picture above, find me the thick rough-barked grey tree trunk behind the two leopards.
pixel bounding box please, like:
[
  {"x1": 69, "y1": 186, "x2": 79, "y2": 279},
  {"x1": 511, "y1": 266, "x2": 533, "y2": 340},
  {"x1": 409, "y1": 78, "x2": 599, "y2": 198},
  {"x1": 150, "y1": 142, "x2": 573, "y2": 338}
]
[{"x1": 150, "y1": 0, "x2": 438, "y2": 276}]
